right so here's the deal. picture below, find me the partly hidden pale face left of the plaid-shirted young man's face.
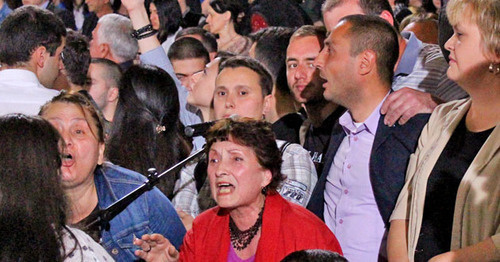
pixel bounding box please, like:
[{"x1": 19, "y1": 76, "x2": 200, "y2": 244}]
[{"x1": 187, "y1": 58, "x2": 220, "y2": 108}]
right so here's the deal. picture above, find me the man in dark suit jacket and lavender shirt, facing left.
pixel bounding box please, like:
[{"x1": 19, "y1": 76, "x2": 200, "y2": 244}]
[{"x1": 308, "y1": 15, "x2": 428, "y2": 261}]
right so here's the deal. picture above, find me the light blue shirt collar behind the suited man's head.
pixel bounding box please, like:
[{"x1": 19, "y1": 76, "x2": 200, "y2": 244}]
[{"x1": 394, "y1": 32, "x2": 423, "y2": 78}]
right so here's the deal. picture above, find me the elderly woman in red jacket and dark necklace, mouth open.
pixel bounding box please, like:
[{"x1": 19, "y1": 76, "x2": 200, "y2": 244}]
[{"x1": 135, "y1": 119, "x2": 342, "y2": 261}]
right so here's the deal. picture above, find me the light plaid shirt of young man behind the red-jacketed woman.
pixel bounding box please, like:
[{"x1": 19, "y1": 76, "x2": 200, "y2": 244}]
[{"x1": 172, "y1": 140, "x2": 318, "y2": 217}]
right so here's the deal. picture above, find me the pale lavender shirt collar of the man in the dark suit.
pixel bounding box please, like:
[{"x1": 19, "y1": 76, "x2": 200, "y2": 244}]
[{"x1": 339, "y1": 92, "x2": 390, "y2": 135}]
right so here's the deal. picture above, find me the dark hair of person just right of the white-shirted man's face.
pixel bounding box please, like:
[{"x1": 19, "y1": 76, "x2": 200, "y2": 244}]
[{"x1": 61, "y1": 29, "x2": 91, "y2": 86}]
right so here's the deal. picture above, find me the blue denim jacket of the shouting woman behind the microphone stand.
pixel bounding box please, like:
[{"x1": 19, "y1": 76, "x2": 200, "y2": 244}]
[{"x1": 94, "y1": 162, "x2": 186, "y2": 261}]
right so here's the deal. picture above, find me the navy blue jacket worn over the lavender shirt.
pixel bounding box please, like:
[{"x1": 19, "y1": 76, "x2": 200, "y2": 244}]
[{"x1": 307, "y1": 114, "x2": 430, "y2": 227}]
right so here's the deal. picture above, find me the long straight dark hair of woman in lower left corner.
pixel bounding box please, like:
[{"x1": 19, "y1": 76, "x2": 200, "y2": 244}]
[{"x1": 0, "y1": 114, "x2": 78, "y2": 261}]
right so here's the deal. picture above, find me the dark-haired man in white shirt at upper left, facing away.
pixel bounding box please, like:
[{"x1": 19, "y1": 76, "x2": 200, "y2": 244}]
[{"x1": 0, "y1": 6, "x2": 66, "y2": 115}]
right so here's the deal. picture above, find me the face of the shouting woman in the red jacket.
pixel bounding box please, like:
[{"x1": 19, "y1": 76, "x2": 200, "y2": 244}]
[{"x1": 207, "y1": 138, "x2": 272, "y2": 209}]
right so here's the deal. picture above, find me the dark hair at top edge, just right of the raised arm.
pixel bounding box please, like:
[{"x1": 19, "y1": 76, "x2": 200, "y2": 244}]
[{"x1": 152, "y1": 0, "x2": 184, "y2": 43}]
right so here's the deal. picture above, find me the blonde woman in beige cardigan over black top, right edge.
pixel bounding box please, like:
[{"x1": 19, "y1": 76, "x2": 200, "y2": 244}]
[{"x1": 388, "y1": 0, "x2": 500, "y2": 261}]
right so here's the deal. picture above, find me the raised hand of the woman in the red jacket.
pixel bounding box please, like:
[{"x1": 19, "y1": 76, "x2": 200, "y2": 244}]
[{"x1": 134, "y1": 234, "x2": 179, "y2": 262}]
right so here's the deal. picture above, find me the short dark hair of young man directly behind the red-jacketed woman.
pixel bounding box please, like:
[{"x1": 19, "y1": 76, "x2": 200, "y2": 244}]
[{"x1": 219, "y1": 56, "x2": 273, "y2": 96}]
